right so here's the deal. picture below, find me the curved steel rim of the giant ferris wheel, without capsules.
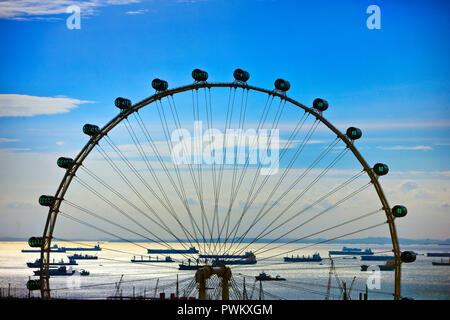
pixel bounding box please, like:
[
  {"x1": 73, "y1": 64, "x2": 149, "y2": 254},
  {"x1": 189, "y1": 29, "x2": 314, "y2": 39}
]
[{"x1": 39, "y1": 81, "x2": 401, "y2": 300}]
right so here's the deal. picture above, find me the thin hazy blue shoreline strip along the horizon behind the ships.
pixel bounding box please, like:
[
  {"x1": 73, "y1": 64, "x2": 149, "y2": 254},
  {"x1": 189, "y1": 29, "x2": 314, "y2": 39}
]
[{"x1": 0, "y1": 237, "x2": 450, "y2": 246}]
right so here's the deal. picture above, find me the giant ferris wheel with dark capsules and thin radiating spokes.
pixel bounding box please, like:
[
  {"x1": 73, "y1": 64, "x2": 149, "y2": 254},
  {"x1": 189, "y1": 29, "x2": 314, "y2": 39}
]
[{"x1": 28, "y1": 69, "x2": 415, "y2": 299}]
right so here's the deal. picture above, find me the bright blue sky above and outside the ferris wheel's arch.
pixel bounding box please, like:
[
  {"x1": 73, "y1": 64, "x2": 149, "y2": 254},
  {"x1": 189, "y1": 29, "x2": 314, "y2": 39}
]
[{"x1": 0, "y1": 0, "x2": 450, "y2": 238}]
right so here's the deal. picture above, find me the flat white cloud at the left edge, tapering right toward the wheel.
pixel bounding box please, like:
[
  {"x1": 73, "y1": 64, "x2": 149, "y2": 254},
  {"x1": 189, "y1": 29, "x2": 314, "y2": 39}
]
[{"x1": 0, "y1": 94, "x2": 92, "y2": 117}]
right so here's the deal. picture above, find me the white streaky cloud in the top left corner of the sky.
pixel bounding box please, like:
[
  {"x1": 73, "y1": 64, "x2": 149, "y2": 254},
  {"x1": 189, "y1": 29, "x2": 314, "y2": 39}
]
[{"x1": 0, "y1": 0, "x2": 141, "y2": 20}]
